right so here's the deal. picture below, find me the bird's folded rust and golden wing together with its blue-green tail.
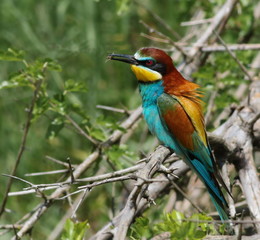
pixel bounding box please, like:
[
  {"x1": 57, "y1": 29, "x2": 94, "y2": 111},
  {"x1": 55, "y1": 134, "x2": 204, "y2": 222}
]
[{"x1": 157, "y1": 93, "x2": 230, "y2": 211}]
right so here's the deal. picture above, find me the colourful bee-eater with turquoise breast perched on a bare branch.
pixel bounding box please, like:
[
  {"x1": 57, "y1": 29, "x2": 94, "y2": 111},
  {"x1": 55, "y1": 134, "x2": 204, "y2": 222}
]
[{"x1": 107, "y1": 47, "x2": 231, "y2": 222}]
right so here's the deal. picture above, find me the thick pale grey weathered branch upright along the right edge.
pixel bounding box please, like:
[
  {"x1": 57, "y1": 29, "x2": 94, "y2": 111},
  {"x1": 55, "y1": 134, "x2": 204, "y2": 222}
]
[{"x1": 214, "y1": 81, "x2": 260, "y2": 232}]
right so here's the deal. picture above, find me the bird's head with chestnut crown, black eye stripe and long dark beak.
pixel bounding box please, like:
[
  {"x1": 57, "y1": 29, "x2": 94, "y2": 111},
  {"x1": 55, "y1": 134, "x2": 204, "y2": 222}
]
[{"x1": 108, "y1": 48, "x2": 175, "y2": 82}]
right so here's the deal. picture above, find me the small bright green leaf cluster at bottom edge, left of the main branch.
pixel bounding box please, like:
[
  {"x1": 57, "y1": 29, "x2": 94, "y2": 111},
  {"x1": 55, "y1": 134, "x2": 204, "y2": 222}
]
[{"x1": 61, "y1": 219, "x2": 89, "y2": 240}]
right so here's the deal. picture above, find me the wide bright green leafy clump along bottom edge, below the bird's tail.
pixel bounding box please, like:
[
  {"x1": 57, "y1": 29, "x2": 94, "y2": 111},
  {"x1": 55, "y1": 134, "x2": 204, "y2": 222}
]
[{"x1": 130, "y1": 211, "x2": 216, "y2": 240}]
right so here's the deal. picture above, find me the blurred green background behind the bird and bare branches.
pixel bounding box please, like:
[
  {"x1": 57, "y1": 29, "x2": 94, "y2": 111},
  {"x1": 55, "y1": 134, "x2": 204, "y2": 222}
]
[{"x1": 0, "y1": 0, "x2": 259, "y2": 239}]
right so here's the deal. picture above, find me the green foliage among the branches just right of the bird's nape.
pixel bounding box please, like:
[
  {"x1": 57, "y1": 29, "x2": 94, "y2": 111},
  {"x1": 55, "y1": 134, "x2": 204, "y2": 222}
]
[{"x1": 193, "y1": 52, "x2": 253, "y2": 126}]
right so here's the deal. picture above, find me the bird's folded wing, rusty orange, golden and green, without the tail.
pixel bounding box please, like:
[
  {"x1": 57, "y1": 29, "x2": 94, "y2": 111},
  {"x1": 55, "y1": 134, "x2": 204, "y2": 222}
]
[{"x1": 157, "y1": 93, "x2": 214, "y2": 172}]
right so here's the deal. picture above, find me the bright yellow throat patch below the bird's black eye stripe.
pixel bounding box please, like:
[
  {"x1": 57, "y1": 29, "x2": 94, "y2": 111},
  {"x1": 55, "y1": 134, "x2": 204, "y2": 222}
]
[{"x1": 131, "y1": 65, "x2": 162, "y2": 82}]
